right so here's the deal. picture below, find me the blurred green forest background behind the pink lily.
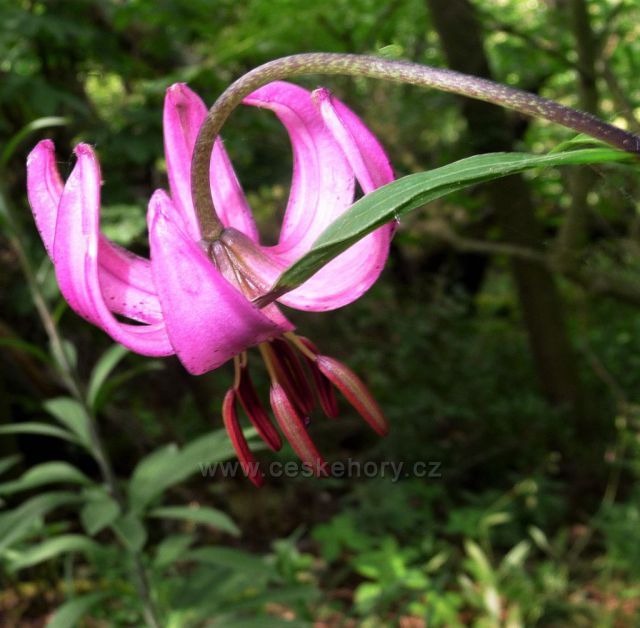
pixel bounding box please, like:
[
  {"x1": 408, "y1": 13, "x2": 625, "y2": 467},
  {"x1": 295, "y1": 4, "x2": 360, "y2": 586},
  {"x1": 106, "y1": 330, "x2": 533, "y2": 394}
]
[{"x1": 0, "y1": 0, "x2": 640, "y2": 627}]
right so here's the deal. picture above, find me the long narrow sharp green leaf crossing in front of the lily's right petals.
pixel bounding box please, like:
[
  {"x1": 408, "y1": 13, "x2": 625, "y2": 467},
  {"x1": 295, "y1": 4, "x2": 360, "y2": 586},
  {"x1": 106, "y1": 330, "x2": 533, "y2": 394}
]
[{"x1": 268, "y1": 148, "x2": 632, "y2": 301}]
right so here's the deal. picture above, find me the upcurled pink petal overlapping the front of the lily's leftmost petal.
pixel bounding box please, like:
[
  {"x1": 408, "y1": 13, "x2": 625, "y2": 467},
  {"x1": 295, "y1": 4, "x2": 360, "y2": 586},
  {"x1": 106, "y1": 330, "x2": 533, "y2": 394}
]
[{"x1": 52, "y1": 144, "x2": 173, "y2": 356}]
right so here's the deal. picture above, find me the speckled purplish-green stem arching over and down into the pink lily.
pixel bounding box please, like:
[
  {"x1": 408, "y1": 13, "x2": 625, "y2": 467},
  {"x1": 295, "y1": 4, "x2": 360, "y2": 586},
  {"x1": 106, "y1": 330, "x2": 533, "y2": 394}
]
[{"x1": 191, "y1": 52, "x2": 640, "y2": 240}]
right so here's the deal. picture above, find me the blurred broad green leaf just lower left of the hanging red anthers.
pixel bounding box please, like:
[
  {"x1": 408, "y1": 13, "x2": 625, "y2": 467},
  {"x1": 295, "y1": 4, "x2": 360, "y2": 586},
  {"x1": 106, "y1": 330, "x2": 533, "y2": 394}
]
[{"x1": 129, "y1": 430, "x2": 250, "y2": 512}]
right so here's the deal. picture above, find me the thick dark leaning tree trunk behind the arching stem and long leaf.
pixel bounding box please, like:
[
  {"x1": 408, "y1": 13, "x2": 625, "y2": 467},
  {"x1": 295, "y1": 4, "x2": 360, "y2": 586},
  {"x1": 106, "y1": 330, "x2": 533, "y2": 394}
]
[{"x1": 427, "y1": 0, "x2": 583, "y2": 421}]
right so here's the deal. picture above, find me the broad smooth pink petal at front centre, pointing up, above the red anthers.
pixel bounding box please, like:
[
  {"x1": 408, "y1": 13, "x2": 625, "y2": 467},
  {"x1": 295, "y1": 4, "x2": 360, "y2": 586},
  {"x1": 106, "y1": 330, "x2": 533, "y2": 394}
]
[{"x1": 148, "y1": 190, "x2": 290, "y2": 375}]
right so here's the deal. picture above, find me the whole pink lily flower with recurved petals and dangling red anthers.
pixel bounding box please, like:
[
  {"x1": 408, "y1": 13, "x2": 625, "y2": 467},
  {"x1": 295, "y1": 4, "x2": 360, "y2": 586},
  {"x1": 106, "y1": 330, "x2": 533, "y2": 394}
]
[{"x1": 27, "y1": 82, "x2": 393, "y2": 485}]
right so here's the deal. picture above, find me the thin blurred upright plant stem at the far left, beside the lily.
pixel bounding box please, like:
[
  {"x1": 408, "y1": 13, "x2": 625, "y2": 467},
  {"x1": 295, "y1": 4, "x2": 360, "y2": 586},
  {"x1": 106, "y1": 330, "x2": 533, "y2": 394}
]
[{"x1": 0, "y1": 189, "x2": 161, "y2": 628}]
